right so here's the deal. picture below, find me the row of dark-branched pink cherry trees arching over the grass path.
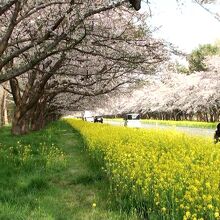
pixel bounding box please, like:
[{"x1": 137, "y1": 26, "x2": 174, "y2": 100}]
[{"x1": 0, "y1": 0, "x2": 167, "y2": 135}]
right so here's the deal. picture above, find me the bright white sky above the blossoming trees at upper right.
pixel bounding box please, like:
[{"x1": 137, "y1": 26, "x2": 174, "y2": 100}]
[{"x1": 142, "y1": 0, "x2": 220, "y2": 52}]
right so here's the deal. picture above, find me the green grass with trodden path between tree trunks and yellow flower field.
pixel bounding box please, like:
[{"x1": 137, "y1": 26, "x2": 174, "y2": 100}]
[{"x1": 0, "y1": 122, "x2": 135, "y2": 220}]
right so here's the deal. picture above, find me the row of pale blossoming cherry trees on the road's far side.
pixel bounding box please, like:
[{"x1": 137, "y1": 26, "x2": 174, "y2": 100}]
[{"x1": 99, "y1": 56, "x2": 220, "y2": 122}]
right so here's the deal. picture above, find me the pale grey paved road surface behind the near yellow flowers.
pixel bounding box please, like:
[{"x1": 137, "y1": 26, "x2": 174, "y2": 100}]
[{"x1": 105, "y1": 121, "x2": 215, "y2": 138}]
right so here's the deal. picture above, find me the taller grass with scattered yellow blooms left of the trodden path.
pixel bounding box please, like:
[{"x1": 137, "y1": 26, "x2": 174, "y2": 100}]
[{"x1": 0, "y1": 125, "x2": 67, "y2": 219}]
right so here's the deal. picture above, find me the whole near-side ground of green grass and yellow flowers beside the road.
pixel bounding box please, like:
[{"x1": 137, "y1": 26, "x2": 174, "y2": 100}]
[{"x1": 0, "y1": 119, "x2": 220, "y2": 220}]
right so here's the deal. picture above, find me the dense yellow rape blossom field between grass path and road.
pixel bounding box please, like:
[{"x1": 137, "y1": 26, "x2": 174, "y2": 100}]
[{"x1": 67, "y1": 119, "x2": 220, "y2": 220}]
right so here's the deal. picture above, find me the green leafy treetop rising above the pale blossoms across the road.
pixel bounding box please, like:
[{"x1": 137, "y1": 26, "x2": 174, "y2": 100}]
[{"x1": 188, "y1": 44, "x2": 220, "y2": 72}]
